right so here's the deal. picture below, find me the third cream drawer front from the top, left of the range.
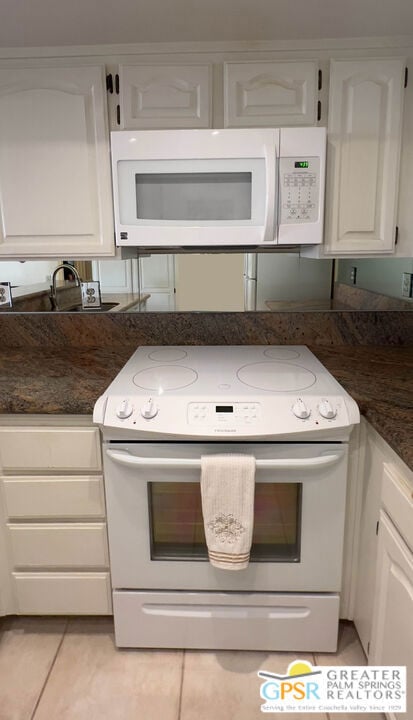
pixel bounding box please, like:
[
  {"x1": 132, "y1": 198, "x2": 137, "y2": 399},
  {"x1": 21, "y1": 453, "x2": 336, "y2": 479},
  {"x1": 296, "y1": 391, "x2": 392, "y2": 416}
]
[{"x1": 7, "y1": 523, "x2": 109, "y2": 569}]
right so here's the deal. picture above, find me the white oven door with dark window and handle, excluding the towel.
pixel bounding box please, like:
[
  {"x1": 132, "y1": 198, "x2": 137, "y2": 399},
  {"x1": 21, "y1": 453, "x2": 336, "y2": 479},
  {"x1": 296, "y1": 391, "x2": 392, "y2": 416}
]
[{"x1": 104, "y1": 442, "x2": 347, "y2": 592}]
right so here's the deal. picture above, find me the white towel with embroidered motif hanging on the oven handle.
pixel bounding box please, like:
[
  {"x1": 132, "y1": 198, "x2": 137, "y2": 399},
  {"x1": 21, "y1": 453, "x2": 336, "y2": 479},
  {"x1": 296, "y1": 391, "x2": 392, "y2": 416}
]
[{"x1": 201, "y1": 455, "x2": 255, "y2": 570}]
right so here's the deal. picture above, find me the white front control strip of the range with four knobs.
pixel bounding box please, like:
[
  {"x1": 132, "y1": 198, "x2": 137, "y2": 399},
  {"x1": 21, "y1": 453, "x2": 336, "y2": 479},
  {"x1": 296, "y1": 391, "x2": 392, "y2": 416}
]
[{"x1": 98, "y1": 392, "x2": 359, "y2": 440}]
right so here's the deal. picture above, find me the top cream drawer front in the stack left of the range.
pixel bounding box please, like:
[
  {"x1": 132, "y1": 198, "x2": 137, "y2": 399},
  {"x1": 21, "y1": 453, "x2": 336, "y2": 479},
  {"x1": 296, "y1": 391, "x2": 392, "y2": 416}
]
[{"x1": 0, "y1": 427, "x2": 102, "y2": 473}]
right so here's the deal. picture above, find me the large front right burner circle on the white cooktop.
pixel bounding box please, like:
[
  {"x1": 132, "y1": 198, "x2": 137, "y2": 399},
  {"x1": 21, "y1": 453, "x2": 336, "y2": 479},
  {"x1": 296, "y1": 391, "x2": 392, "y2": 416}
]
[{"x1": 237, "y1": 362, "x2": 317, "y2": 392}]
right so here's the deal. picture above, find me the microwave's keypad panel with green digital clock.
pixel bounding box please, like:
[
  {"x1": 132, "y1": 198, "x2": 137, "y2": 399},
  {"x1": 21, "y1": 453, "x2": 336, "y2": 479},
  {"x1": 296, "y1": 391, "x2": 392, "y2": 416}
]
[{"x1": 280, "y1": 156, "x2": 320, "y2": 224}]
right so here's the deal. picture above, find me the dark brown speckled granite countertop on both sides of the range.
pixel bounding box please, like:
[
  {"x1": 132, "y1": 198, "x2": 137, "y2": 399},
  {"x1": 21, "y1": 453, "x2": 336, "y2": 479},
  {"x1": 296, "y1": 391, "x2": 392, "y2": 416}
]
[{"x1": 0, "y1": 345, "x2": 413, "y2": 470}]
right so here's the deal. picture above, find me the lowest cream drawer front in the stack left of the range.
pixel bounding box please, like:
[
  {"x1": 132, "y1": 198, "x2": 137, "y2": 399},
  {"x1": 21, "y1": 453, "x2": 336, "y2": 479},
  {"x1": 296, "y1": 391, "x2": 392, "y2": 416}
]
[{"x1": 13, "y1": 573, "x2": 112, "y2": 615}]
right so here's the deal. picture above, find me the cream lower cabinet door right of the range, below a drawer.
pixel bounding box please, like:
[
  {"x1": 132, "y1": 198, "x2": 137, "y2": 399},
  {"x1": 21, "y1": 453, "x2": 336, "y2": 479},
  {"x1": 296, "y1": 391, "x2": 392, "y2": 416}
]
[{"x1": 369, "y1": 511, "x2": 413, "y2": 719}]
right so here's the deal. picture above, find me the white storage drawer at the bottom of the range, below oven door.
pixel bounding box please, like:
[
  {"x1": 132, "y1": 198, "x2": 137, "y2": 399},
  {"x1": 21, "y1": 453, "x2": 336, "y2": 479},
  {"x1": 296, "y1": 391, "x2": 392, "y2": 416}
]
[{"x1": 113, "y1": 590, "x2": 339, "y2": 652}]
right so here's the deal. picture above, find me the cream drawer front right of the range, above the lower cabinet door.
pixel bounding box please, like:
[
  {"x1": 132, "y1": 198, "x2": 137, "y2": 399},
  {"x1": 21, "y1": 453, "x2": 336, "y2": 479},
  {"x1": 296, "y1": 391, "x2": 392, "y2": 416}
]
[{"x1": 382, "y1": 463, "x2": 413, "y2": 550}]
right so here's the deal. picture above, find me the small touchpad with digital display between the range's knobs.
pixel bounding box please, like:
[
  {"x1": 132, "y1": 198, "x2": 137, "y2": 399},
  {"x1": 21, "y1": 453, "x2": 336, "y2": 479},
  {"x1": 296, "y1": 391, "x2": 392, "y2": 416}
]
[{"x1": 188, "y1": 402, "x2": 261, "y2": 427}]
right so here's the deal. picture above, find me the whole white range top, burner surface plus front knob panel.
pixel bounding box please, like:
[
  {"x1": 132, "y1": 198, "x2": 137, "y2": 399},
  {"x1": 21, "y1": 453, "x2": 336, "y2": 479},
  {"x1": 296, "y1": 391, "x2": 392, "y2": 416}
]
[{"x1": 94, "y1": 345, "x2": 360, "y2": 442}]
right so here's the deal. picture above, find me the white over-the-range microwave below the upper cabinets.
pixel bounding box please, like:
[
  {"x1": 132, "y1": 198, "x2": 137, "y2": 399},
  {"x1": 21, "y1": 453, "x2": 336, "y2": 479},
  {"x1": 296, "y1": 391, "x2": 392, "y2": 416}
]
[{"x1": 111, "y1": 127, "x2": 326, "y2": 249}]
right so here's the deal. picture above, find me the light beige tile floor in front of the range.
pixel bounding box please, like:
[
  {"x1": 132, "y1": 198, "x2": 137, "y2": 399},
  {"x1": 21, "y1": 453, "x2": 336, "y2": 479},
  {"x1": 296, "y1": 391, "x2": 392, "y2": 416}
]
[{"x1": 0, "y1": 618, "x2": 384, "y2": 720}]
